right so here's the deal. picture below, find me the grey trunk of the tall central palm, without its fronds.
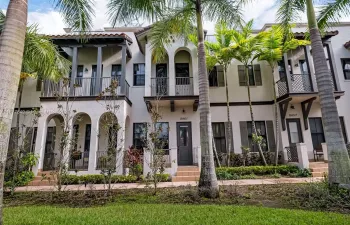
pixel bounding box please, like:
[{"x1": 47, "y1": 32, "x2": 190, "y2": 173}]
[{"x1": 196, "y1": 0, "x2": 219, "y2": 198}]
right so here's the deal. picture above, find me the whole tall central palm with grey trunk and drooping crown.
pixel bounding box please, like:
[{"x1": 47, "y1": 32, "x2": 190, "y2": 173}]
[{"x1": 108, "y1": 0, "x2": 241, "y2": 197}]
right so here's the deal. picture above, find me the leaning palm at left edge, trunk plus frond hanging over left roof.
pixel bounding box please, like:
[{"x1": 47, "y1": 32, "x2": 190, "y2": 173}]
[{"x1": 0, "y1": 0, "x2": 94, "y2": 221}]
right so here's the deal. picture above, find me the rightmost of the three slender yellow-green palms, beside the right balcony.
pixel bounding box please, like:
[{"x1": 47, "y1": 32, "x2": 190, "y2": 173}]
[{"x1": 258, "y1": 26, "x2": 310, "y2": 165}]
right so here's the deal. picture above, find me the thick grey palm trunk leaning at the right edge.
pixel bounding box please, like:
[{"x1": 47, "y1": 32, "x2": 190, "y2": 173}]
[{"x1": 306, "y1": 0, "x2": 350, "y2": 186}]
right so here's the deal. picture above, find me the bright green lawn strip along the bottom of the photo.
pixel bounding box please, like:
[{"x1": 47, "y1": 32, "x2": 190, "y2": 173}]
[{"x1": 4, "y1": 204, "x2": 350, "y2": 225}]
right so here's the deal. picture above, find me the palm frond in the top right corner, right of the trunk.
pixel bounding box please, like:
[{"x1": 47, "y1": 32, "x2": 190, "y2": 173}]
[{"x1": 317, "y1": 0, "x2": 350, "y2": 29}]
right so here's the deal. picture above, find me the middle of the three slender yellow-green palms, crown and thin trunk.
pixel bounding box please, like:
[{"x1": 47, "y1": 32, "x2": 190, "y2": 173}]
[{"x1": 227, "y1": 20, "x2": 267, "y2": 165}]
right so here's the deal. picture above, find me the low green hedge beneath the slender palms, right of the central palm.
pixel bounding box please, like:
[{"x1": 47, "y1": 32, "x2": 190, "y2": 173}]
[{"x1": 216, "y1": 165, "x2": 311, "y2": 180}]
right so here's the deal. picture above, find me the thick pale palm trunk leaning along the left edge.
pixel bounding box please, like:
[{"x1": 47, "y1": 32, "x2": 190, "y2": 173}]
[{"x1": 0, "y1": 0, "x2": 28, "y2": 221}]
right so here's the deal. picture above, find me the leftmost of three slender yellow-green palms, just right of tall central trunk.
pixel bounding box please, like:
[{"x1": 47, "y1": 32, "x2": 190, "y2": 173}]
[{"x1": 205, "y1": 22, "x2": 233, "y2": 166}]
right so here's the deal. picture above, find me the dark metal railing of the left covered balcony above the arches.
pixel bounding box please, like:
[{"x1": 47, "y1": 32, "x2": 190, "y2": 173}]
[{"x1": 42, "y1": 76, "x2": 130, "y2": 99}]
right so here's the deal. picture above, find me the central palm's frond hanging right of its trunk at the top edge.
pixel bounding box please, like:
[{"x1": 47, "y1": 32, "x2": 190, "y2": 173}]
[{"x1": 202, "y1": 0, "x2": 245, "y2": 27}]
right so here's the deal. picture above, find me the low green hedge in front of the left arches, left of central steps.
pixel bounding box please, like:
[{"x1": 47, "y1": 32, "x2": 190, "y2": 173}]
[{"x1": 63, "y1": 174, "x2": 170, "y2": 185}]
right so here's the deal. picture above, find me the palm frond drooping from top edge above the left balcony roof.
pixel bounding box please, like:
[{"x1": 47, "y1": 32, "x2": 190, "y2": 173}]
[{"x1": 55, "y1": 0, "x2": 95, "y2": 33}]
